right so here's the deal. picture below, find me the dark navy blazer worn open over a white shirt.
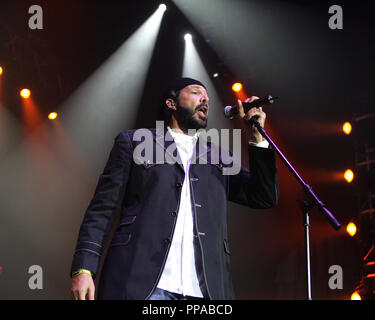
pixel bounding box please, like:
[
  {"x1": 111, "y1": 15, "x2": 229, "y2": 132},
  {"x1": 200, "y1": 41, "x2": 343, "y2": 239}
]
[{"x1": 71, "y1": 129, "x2": 278, "y2": 300}]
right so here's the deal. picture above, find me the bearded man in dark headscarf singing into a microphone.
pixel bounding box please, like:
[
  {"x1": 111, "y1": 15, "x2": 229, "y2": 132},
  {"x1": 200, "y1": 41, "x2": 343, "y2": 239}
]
[{"x1": 71, "y1": 78, "x2": 278, "y2": 300}]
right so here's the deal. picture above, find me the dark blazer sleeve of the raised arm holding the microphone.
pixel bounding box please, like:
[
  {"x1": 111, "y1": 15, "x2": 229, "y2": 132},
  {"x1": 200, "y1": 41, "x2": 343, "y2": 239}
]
[{"x1": 228, "y1": 145, "x2": 279, "y2": 209}]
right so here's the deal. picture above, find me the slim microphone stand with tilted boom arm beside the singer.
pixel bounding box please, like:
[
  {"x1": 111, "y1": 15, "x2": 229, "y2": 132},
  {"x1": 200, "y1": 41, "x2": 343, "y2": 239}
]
[{"x1": 250, "y1": 117, "x2": 341, "y2": 300}]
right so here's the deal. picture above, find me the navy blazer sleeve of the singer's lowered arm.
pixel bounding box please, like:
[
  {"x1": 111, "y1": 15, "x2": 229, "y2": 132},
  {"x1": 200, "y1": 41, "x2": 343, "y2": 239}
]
[{"x1": 71, "y1": 132, "x2": 133, "y2": 276}]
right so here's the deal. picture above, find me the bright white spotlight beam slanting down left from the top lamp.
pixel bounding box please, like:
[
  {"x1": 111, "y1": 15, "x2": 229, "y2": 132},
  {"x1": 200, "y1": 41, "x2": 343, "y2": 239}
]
[{"x1": 60, "y1": 6, "x2": 166, "y2": 170}]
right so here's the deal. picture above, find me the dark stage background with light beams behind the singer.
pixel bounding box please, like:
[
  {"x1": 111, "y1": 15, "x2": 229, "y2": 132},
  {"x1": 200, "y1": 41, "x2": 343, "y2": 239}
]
[{"x1": 0, "y1": 0, "x2": 375, "y2": 299}]
